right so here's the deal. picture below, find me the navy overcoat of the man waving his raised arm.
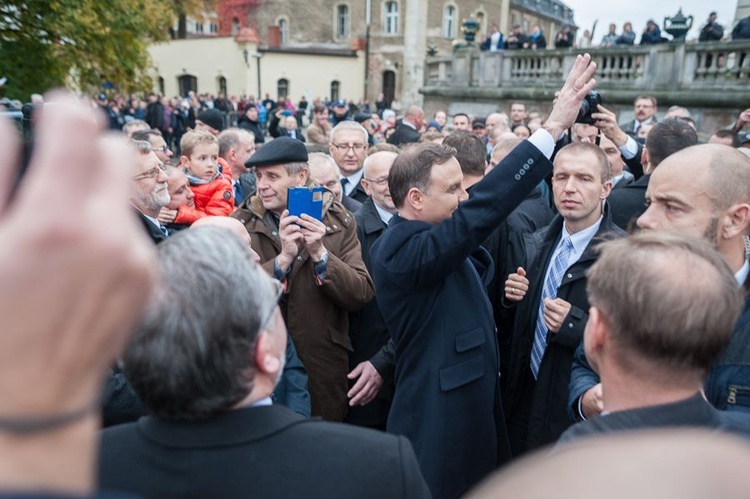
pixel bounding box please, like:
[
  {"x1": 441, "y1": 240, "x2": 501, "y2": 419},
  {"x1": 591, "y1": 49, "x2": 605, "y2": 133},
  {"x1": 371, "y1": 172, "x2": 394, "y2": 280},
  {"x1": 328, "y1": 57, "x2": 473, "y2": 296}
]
[{"x1": 370, "y1": 141, "x2": 552, "y2": 498}]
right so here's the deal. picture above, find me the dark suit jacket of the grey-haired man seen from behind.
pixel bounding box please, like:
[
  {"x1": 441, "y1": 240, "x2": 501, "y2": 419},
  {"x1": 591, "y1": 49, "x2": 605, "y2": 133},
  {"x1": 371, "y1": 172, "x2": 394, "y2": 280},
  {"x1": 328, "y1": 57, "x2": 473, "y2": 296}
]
[{"x1": 99, "y1": 405, "x2": 429, "y2": 499}]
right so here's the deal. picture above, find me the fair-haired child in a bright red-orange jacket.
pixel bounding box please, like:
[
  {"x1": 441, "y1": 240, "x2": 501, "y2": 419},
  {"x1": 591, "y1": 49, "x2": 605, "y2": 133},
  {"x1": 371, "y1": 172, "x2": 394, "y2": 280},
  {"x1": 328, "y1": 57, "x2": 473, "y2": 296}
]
[{"x1": 174, "y1": 131, "x2": 234, "y2": 224}]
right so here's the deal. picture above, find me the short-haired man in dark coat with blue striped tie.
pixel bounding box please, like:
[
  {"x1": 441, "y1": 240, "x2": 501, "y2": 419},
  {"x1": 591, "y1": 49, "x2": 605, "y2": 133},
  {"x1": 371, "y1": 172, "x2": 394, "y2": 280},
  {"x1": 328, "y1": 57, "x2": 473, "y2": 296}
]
[{"x1": 504, "y1": 142, "x2": 624, "y2": 455}]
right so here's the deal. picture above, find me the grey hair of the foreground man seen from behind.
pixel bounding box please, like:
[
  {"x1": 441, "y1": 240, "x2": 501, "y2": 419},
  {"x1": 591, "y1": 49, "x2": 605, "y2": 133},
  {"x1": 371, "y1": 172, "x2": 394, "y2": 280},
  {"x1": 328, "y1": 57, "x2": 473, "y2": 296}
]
[{"x1": 123, "y1": 226, "x2": 276, "y2": 421}]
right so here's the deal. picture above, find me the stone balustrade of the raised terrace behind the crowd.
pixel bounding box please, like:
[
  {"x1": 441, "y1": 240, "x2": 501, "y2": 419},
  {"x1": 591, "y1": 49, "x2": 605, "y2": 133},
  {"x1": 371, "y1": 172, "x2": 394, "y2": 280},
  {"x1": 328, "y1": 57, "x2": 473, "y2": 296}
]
[{"x1": 422, "y1": 41, "x2": 750, "y2": 107}]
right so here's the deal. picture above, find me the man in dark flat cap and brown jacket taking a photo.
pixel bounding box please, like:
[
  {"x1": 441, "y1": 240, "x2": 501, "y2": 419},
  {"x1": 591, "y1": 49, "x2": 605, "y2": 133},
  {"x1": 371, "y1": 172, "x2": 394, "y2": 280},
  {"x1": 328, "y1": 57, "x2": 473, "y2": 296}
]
[{"x1": 232, "y1": 137, "x2": 374, "y2": 421}]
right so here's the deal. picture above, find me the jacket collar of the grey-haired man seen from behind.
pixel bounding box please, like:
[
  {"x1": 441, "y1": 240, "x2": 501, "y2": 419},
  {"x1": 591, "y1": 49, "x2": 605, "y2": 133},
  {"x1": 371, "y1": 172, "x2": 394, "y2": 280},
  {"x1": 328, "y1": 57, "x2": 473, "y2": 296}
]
[{"x1": 136, "y1": 405, "x2": 310, "y2": 449}]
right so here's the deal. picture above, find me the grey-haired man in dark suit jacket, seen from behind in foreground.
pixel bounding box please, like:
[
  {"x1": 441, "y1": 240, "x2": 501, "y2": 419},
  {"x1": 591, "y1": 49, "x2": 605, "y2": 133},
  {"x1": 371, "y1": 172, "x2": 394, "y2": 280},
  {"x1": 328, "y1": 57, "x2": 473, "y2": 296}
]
[{"x1": 99, "y1": 228, "x2": 429, "y2": 498}]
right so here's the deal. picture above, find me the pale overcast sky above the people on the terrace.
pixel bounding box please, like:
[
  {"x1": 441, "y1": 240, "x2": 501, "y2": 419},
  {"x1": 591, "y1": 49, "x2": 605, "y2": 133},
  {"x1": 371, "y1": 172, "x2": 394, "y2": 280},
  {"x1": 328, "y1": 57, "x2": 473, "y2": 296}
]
[{"x1": 563, "y1": 0, "x2": 737, "y2": 44}]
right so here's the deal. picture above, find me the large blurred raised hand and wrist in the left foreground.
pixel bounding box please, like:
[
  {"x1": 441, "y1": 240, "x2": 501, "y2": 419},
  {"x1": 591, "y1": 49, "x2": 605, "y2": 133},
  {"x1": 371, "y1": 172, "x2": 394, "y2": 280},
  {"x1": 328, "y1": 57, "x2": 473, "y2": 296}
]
[{"x1": 0, "y1": 93, "x2": 156, "y2": 497}]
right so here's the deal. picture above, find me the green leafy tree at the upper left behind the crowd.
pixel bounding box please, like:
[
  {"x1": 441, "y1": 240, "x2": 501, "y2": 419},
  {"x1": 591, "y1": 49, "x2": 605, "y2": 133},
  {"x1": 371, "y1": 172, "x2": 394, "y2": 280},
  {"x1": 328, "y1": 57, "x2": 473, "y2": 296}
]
[{"x1": 0, "y1": 0, "x2": 206, "y2": 100}]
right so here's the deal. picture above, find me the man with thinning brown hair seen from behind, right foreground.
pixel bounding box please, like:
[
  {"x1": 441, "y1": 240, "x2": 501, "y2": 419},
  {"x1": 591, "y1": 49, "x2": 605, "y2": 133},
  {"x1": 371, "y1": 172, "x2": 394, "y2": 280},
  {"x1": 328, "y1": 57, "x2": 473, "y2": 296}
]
[{"x1": 559, "y1": 232, "x2": 750, "y2": 444}]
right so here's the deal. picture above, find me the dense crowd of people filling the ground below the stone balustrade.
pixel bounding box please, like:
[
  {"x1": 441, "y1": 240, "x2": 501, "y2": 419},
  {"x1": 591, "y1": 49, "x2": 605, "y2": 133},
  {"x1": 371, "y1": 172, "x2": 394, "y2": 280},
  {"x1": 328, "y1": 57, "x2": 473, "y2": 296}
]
[{"x1": 0, "y1": 51, "x2": 750, "y2": 498}]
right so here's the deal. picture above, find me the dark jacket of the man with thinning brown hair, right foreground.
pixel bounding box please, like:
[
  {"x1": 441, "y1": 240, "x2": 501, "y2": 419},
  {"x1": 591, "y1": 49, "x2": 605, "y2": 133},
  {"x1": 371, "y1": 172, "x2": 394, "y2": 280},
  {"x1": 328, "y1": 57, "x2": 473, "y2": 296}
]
[{"x1": 558, "y1": 394, "x2": 750, "y2": 444}]
